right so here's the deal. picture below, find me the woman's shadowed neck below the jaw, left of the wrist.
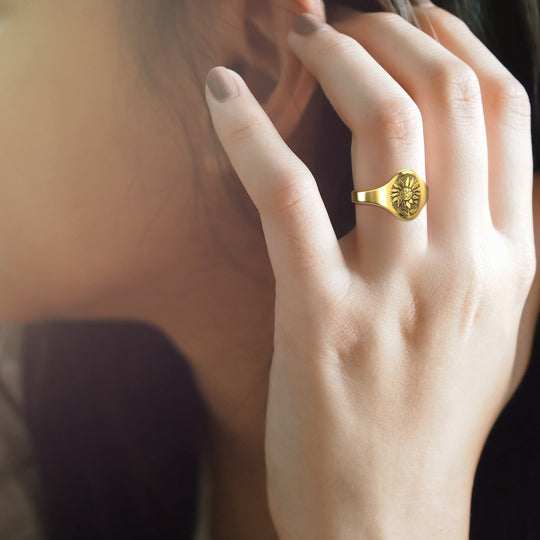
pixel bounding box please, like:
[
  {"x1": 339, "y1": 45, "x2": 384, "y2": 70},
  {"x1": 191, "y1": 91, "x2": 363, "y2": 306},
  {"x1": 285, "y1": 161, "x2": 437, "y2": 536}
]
[{"x1": 153, "y1": 217, "x2": 277, "y2": 540}]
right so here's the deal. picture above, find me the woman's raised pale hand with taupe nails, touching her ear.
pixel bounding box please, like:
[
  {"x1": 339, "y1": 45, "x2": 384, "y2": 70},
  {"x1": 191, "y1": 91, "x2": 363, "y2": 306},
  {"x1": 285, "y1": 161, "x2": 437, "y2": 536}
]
[{"x1": 207, "y1": 7, "x2": 535, "y2": 540}]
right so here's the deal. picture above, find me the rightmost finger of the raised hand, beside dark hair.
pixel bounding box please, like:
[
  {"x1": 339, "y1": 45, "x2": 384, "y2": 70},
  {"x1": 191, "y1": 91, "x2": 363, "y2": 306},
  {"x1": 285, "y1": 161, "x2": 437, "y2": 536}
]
[{"x1": 416, "y1": 8, "x2": 533, "y2": 239}]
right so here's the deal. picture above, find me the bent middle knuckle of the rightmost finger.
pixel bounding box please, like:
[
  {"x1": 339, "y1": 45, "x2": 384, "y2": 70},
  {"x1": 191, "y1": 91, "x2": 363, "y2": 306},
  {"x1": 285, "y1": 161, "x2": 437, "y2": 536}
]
[{"x1": 485, "y1": 76, "x2": 531, "y2": 123}]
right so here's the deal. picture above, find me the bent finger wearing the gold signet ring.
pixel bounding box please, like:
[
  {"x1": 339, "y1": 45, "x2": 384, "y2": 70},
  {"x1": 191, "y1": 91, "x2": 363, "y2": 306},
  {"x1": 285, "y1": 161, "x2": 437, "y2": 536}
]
[{"x1": 289, "y1": 15, "x2": 427, "y2": 274}]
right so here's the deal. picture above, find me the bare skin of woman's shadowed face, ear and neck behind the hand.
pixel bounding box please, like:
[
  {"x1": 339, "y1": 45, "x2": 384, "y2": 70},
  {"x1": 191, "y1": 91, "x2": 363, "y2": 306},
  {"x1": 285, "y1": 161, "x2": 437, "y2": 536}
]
[{"x1": 0, "y1": 0, "x2": 540, "y2": 539}]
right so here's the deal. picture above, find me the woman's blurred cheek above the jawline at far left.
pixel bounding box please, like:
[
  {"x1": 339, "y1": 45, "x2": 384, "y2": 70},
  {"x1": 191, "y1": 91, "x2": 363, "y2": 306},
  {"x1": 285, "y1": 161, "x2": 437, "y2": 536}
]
[{"x1": 0, "y1": 102, "x2": 194, "y2": 319}]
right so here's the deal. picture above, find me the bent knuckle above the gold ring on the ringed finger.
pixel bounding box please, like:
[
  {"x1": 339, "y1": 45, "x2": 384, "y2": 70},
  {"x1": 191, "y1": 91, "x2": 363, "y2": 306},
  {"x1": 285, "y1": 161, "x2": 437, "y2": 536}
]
[{"x1": 368, "y1": 98, "x2": 423, "y2": 147}]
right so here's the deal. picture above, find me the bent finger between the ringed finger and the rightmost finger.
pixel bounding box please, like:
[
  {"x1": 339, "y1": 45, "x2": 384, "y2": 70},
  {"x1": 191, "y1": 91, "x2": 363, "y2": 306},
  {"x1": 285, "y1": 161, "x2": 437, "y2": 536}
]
[{"x1": 330, "y1": 12, "x2": 492, "y2": 250}]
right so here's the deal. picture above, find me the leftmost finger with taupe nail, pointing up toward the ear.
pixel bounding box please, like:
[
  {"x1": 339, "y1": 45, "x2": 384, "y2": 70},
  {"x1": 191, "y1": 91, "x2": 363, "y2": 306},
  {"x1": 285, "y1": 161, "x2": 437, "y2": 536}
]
[{"x1": 206, "y1": 67, "x2": 343, "y2": 293}]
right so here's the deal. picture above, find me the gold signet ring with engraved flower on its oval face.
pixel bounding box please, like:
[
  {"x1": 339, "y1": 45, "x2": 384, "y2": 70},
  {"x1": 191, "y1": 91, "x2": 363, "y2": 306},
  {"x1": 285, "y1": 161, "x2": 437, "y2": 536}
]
[{"x1": 351, "y1": 169, "x2": 429, "y2": 221}]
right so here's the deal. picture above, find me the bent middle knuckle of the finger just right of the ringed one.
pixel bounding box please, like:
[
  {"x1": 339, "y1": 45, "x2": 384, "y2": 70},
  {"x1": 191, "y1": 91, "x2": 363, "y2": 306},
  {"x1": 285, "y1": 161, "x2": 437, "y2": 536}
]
[{"x1": 431, "y1": 60, "x2": 482, "y2": 115}]
